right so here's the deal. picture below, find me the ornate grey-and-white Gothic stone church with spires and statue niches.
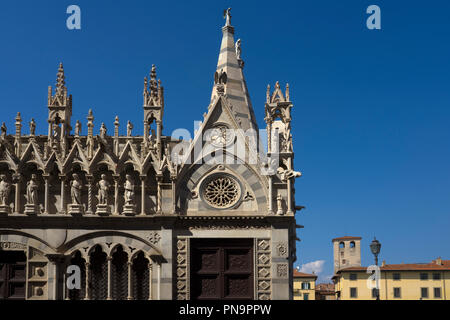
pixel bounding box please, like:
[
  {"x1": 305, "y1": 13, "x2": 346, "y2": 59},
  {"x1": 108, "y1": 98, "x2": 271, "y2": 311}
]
[{"x1": 0, "y1": 10, "x2": 302, "y2": 300}]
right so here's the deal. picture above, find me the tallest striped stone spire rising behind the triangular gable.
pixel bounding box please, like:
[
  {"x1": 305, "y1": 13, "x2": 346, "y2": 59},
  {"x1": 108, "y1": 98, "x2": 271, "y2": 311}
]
[{"x1": 211, "y1": 8, "x2": 258, "y2": 130}]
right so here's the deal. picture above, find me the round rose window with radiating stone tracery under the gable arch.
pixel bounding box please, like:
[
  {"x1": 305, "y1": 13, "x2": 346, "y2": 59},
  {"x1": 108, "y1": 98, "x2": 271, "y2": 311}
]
[{"x1": 202, "y1": 175, "x2": 241, "y2": 209}]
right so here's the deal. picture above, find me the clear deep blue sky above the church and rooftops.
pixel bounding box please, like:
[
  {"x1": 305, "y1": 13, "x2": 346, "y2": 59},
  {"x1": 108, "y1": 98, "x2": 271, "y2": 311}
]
[{"x1": 0, "y1": 0, "x2": 450, "y2": 282}]
